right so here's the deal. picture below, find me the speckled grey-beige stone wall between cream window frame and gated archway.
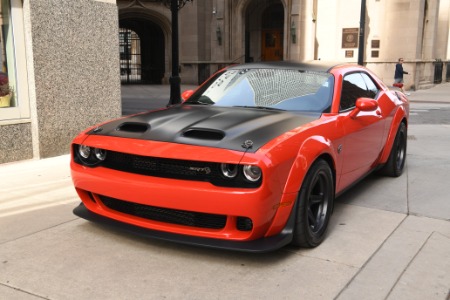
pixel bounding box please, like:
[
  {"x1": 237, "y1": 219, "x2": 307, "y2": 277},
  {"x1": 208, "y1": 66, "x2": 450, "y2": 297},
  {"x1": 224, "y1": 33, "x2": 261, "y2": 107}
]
[{"x1": 26, "y1": 0, "x2": 121, "y2": 158}]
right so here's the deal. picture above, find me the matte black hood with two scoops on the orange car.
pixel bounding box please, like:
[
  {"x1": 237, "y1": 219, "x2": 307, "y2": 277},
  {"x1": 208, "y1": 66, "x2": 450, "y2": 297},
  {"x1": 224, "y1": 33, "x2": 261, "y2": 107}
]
[{"x1": 89, "y1": 105, "x2": 318, "y2": 152}]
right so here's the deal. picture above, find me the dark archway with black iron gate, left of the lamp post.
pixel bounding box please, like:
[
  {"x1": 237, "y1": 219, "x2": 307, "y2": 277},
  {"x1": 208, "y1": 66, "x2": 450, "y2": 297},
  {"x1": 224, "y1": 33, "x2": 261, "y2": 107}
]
[{"x1": 119, "y1": 18, "x2": 165, "y2": 84}]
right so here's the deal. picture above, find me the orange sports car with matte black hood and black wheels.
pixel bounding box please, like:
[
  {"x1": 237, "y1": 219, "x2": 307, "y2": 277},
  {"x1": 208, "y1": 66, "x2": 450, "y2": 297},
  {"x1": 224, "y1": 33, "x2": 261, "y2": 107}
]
[{"x1": 71, "y1": 62, "x2": 409, "y2": 252}]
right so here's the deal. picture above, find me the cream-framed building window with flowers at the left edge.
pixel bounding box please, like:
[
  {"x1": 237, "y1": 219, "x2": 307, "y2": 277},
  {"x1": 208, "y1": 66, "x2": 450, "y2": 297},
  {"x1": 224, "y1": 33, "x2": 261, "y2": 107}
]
[{"x1": 0, "y1": 0, "x2": 30, "y2": 125}]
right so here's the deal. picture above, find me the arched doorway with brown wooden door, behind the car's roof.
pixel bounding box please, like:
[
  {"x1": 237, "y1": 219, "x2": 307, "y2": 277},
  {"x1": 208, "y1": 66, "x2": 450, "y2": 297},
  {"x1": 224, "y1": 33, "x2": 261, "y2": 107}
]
[{"x1": 245, "y1": 0, "x2": 285, "y2": 62}]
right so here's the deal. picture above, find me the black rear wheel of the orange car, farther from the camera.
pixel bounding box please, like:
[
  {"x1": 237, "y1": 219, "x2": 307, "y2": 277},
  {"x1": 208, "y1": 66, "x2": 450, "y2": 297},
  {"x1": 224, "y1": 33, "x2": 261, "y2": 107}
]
[{"x1": 381, "y1": 123, "x2": 408, "y2": 177}]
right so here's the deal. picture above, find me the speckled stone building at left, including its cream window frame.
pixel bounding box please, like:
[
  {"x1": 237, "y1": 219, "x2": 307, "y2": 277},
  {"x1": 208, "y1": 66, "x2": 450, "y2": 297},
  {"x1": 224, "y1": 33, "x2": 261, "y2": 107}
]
[{"x1": 0, "y1": 0, "x2": 121, "y2": 163}]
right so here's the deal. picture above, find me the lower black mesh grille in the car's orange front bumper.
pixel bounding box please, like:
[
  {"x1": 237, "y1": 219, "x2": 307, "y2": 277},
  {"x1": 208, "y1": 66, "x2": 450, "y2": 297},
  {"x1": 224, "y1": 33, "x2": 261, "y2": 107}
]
[{"x1": 99, "y1": 196, "x2": 227, "y2": 229}]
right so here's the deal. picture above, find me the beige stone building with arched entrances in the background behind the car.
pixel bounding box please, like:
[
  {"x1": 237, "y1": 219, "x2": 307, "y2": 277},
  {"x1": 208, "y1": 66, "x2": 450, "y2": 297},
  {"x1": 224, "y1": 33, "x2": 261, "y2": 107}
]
[{"x1": 117, "y1": 0, "x2": 450, "y2": 89}]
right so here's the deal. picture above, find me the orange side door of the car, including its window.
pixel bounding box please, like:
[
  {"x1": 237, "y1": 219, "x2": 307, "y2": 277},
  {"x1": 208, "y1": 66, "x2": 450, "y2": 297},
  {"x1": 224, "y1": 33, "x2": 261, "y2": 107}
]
[{"x1": 338, "y1": 72, "x2": 384, "y2": 188}]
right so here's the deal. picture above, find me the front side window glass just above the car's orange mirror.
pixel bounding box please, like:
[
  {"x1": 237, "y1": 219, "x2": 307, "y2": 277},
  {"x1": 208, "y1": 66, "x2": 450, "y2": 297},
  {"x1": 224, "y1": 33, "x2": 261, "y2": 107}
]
[{"x1": 340, "y1": 73, "x2": 369, "y2": 111}]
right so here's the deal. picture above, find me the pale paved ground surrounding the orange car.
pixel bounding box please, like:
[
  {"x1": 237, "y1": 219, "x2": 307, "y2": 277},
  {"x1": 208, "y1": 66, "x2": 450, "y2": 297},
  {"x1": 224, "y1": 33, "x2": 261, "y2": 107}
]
[{"x1": 0, "y1": 83, "x2": 450, "y2": 300}]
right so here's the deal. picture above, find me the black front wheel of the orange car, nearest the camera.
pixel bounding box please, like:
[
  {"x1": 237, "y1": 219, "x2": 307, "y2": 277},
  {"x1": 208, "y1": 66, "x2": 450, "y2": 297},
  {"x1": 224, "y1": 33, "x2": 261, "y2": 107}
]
[{"x1": 292, "y1": 159, "x2": 334, "y2": 248}]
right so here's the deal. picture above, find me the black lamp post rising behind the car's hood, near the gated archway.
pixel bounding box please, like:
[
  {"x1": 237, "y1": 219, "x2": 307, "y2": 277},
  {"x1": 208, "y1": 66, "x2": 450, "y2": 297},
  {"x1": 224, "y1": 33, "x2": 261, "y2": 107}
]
[{"x1": 153, "y1": 0, "x2": 194, "y2": 106}]
